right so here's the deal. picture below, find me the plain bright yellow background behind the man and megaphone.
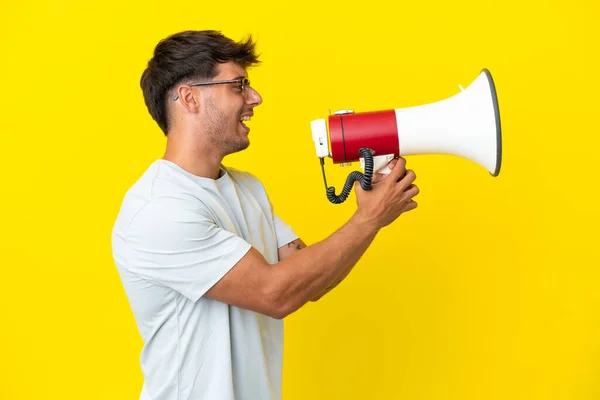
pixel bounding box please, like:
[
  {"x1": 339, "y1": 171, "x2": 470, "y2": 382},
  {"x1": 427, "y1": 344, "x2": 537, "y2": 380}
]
[{"x1": 0, "y1": 0, "x2": 600, "y2": 400}]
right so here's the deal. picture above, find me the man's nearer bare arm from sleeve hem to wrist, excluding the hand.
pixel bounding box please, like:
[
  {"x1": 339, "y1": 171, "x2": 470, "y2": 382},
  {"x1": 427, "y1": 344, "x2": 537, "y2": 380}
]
[{"x1": 206, "y1": 209, "x2": 379, "y2": 318}]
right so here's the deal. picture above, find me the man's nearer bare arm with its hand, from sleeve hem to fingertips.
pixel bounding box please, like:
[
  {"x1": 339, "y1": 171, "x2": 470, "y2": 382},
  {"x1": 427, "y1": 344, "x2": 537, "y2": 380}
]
[{"x1": 206, "y1": 159, "x2": 419, "y2": 318}]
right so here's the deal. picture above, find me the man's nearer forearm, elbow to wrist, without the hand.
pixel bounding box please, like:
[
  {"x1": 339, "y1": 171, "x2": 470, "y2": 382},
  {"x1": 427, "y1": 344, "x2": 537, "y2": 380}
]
[{"x1": 269, "y1": 214, "x2": 378, "y2": 315}]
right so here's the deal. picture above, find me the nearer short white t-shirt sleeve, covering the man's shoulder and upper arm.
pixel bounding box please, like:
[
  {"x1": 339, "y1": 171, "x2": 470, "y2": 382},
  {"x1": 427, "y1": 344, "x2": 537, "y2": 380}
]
[{"x1": 124, "y1": 198, "x2": 251, "y2": 301}]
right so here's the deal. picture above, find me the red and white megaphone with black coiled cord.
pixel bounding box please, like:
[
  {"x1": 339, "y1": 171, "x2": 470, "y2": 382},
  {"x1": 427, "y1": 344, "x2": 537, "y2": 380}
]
[{"x1": 311, "y1": 68, "x2": 502, "y2": 204}]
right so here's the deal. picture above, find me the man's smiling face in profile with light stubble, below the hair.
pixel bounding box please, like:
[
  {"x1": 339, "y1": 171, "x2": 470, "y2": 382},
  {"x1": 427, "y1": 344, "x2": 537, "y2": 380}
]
[{"x1": 200, "y1": 62, "x2": 262, "y2": 155}]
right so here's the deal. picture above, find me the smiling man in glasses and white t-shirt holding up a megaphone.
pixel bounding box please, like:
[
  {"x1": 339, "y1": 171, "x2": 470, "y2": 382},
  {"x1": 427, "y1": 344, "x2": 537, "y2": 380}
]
[{"x1": 112, "y1": 31, "x2": 418, "y2": 400}]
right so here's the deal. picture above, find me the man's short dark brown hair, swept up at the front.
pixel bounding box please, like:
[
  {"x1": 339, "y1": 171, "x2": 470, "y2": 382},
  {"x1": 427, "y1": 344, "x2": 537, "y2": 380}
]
[{"x1": 140, "y1": 30, "x2": 260, "y2": 135}]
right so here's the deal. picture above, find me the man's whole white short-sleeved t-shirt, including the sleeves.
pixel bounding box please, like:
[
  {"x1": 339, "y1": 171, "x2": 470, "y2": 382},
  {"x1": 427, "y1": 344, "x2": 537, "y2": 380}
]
[{"x1": 112, "y1": 160, "x2": 298, "y2": 400}]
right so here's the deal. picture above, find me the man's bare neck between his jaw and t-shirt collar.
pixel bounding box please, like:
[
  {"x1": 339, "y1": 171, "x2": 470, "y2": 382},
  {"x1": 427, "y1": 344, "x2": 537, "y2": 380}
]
[{"x1": 163, "y1": 132, "x2": 223, "y2": 179}]
